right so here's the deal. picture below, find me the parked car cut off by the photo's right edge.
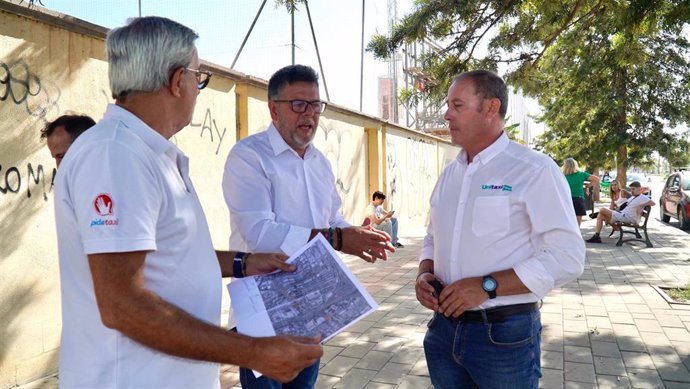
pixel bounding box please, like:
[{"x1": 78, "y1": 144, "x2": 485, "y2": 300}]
[{"x1": 659, "y1": 170, "x2": 690, "y2": 230}]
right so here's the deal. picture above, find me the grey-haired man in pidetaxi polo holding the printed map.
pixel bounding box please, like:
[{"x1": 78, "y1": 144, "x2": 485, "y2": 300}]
[{"x1": 55, "y1": 17, "x2": 323, "y2": 389}]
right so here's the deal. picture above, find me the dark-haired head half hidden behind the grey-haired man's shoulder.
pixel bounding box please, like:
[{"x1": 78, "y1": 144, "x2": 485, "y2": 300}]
[{"x1": 41, "y1": 115, "x2": 96, "y2": 167}]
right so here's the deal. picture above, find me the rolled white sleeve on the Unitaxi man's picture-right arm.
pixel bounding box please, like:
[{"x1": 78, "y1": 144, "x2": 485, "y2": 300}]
[{"x1": 514, "y1": 163, "x2": 585, "y2": 298}]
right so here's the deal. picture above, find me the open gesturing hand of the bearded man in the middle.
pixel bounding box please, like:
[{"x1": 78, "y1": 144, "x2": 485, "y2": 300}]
[{"x1": 340, "y1": 226, "x2": 395, "y2": 263}]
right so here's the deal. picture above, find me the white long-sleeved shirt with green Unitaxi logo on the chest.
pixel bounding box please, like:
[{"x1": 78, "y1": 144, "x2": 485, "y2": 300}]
[{"x1": 420, "y1": 133, "x2": 585, "y2": 309}]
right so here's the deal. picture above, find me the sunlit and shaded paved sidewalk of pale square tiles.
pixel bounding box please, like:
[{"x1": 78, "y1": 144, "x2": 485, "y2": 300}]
[{"x1": 16, "y1": 213, "x2": 690, "y2": 389}]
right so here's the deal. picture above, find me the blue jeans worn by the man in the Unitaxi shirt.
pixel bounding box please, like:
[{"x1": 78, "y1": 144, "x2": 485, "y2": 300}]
[{"x1": 424, "y1": 310, "x2": 541, "y2": 389}]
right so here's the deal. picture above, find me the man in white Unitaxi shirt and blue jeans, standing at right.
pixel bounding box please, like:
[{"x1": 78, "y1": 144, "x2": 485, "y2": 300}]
[{"x1": 415, "y1": 70, "x2": 585, "y2": 389}]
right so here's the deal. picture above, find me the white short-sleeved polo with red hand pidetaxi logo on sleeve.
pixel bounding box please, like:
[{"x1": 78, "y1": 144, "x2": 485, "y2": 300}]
[{"x1": 55, "y1": 105, "x2": 221, "y2": 389}]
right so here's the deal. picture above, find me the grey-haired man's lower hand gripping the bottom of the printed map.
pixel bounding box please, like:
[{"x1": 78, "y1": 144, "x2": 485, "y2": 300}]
[{"x1": 248, "y1": 335, "x2": 323, "y2": 382}]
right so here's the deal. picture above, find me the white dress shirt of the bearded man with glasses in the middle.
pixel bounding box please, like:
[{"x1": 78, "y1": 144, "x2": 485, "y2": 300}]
[{"x1": 223, "y1": 124, "x2": 350, "y2": 255}]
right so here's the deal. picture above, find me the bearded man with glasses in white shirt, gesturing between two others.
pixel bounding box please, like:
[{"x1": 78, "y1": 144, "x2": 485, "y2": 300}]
[{"x1": 223, "y1": 65, "x2": 395, "y2": 389}]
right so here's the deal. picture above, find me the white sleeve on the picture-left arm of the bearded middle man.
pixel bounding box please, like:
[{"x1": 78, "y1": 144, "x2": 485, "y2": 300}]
[{"x1": 223, "y1": 143, "x2": 310, "y2": 255}]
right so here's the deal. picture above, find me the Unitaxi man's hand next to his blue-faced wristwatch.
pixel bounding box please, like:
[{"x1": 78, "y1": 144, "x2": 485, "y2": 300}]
[{"x1": 438, "y1": 277, "x2": 489, "y2": 317}]
